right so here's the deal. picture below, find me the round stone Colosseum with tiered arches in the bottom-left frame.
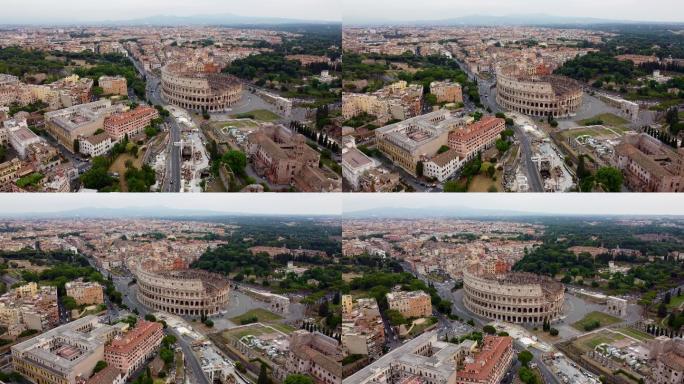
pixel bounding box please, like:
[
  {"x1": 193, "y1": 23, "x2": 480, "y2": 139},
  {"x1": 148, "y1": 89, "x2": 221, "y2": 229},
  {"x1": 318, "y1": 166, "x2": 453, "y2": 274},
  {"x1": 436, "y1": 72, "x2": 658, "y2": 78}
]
[{"x1": 135, "y1": 266, "x2": 229, "y2": 317}]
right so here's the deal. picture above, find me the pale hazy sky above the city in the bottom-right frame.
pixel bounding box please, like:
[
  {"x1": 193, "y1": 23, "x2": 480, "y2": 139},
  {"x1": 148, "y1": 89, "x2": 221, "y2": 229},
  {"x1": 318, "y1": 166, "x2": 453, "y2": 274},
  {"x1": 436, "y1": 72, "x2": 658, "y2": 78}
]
[{"x1": 343, "y1": 193, "x2": 684, "y2": 215}]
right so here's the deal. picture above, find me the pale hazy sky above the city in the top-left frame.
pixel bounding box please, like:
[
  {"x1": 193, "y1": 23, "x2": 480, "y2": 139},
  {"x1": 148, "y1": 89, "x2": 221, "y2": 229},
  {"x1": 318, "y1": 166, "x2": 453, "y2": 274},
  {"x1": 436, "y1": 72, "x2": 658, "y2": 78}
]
[{"x1": 0, "y1": 0, "x2": 341, "y2": 23}]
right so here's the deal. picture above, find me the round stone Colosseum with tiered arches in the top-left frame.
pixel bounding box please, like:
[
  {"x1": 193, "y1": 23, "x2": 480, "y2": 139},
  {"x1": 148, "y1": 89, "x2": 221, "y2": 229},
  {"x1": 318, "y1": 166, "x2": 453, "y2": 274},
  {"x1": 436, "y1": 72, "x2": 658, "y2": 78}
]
[{"x1": 161, "y1": 63, "x2": 242, "y2": 112}]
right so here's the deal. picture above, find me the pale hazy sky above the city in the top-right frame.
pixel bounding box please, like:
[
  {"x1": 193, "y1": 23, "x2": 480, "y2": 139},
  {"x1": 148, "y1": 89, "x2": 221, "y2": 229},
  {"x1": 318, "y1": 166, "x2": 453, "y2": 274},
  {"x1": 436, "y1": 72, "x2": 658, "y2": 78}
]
[{"x1": 341, "y1": 0, "x2": 684, "y2": 21}]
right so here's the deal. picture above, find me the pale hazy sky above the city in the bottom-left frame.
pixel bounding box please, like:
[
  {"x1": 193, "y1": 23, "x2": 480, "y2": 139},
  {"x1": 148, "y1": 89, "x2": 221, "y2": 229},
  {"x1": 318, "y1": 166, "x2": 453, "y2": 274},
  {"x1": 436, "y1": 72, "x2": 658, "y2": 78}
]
[{"x1": 0, "y1": 193, "x2": 342, "y2": 216}]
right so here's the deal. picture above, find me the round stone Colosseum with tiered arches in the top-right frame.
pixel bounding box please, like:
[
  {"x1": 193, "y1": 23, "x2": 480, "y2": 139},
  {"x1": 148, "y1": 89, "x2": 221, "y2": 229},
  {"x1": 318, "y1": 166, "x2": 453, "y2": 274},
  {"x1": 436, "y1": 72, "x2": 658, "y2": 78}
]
[{"x1": 496, "y1": 64, "x2": 582, "y2": 117}]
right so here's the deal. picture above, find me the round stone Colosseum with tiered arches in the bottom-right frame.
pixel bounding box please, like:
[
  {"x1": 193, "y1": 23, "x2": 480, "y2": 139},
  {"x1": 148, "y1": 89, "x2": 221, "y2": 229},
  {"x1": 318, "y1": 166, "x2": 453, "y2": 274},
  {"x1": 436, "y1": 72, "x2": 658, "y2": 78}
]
[{"x1": 463, "y1": 266, "x2": 565, "y2": 324}]
